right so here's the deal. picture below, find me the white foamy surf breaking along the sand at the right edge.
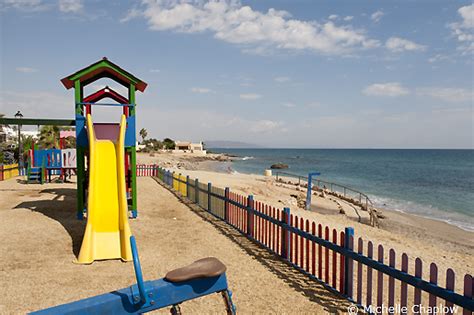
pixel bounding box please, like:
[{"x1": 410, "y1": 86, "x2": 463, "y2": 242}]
[{"x1": 370, "y1": 196, "x2": 474, "y2": 232}]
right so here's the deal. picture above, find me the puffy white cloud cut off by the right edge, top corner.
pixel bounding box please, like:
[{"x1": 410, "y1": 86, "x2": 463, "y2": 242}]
[{"x1": 449, "y1": 4, "x2": 474, "y2": 54}]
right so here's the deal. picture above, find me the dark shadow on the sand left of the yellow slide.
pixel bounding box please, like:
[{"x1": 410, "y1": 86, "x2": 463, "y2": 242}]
[{"x1": 15, "y1": 188, "x2": 86, "y2": 257}]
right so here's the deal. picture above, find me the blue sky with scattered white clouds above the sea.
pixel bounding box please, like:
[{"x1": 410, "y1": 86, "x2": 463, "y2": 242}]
[{"x1": 0, "y1": 0, "x2": 474, "y2": 149}]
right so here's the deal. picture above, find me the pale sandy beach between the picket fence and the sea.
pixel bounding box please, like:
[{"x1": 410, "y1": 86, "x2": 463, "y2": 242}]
[{"x1": 138, "y1": 153, "x2": 474, "y2": 289}]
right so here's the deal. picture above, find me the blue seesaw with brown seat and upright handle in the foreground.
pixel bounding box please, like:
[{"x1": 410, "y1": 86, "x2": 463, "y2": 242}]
[{"x1": 31, "y1": 236, "x2": 235, "y2": 315}]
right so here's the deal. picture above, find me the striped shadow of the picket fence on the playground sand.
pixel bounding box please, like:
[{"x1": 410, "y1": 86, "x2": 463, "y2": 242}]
[{"x1": 154, "y1": 178, "x2": 351, "y2": 314}]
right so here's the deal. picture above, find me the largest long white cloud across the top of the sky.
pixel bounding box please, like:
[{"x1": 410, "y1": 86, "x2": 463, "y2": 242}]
[{"x1": 122, "y1": 0, "x2": 380, "y2": 54}]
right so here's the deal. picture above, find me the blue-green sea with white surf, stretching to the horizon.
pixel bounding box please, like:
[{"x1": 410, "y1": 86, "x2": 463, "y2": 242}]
[{"x1": 211, "y1": 148, "x2": 474, "y2": 231}]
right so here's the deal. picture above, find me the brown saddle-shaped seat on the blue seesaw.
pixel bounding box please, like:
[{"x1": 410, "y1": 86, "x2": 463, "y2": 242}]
[{"x1": 165, "y1": 257, "x2": 227, "y2": 282}]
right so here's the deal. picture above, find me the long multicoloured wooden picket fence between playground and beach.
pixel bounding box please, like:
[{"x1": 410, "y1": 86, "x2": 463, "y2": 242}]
[{"x1": 137, "y1": 166, "x2": 474, "y2": 315}]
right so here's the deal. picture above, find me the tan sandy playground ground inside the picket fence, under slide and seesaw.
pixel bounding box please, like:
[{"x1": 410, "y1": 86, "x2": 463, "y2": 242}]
[{"x1": 0, "y1": 178, "x2": 356, "y2": 314}]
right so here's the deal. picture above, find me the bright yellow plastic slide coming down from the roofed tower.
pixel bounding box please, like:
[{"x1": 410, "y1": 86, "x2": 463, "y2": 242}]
[{"x1": 77, "y1": 114, "x2": 132, "y2": 264}]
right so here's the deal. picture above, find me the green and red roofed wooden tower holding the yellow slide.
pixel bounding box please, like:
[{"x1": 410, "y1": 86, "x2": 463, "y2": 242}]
[{"x1": 61, "y1": 57, "x2": 147, "y2": 219}]
